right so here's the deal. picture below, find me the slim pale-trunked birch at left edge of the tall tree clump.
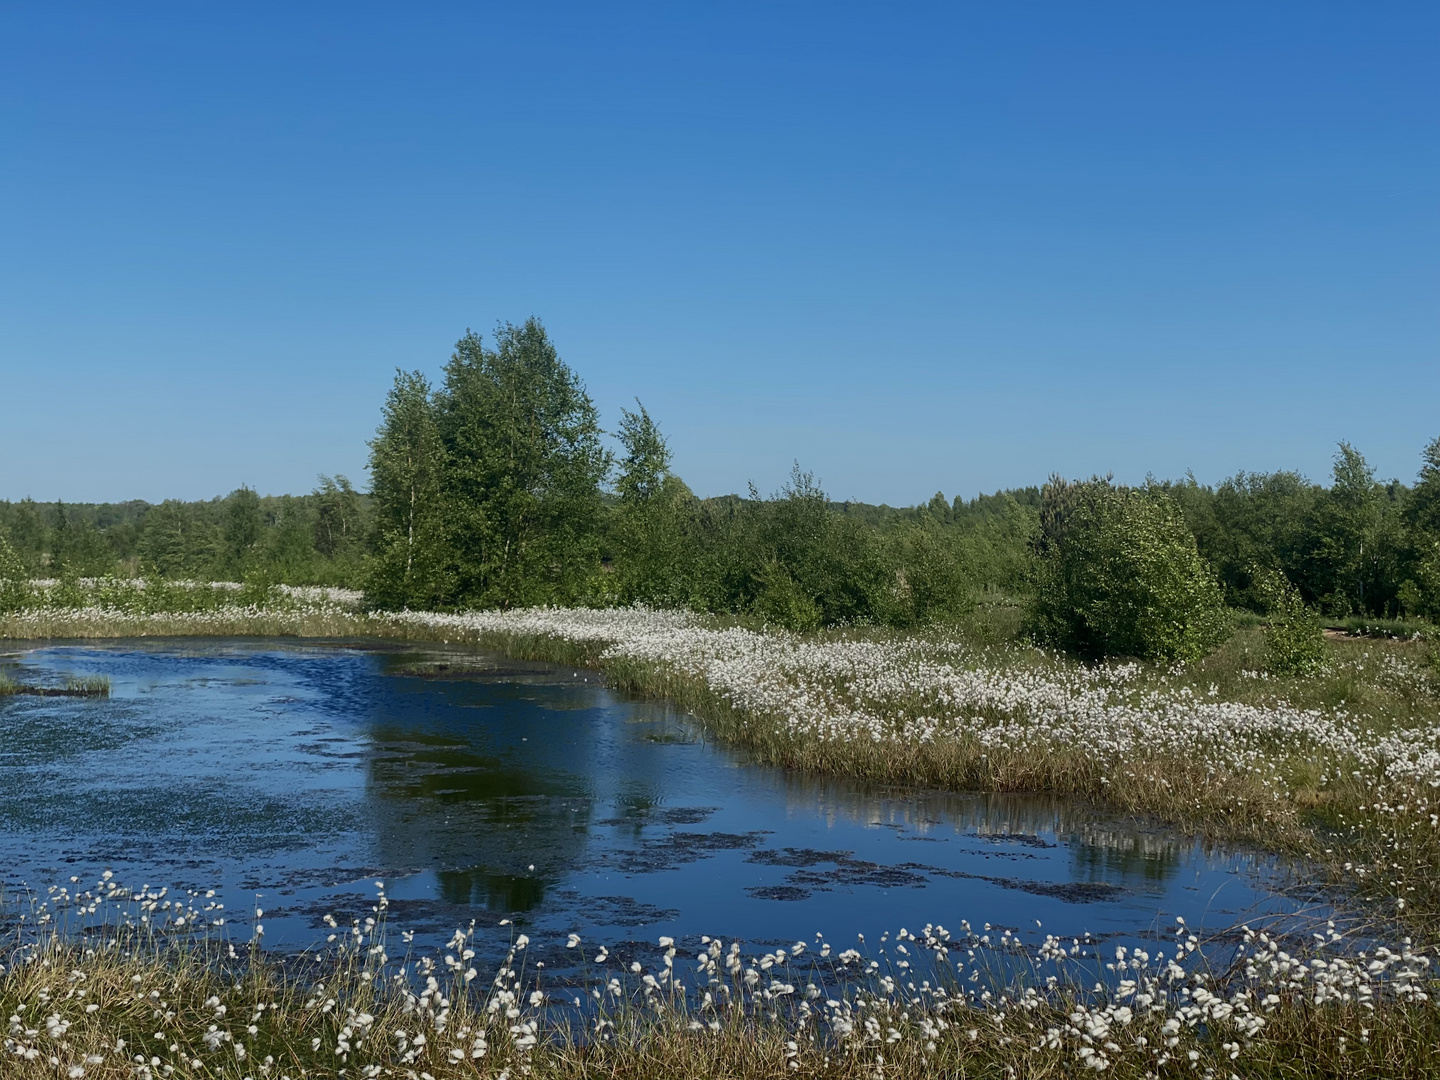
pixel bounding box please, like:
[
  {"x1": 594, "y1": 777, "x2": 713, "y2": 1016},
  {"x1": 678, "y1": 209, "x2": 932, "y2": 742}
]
[{"x1": 366, "y1": 372, "x2": 451, "y2": 608}]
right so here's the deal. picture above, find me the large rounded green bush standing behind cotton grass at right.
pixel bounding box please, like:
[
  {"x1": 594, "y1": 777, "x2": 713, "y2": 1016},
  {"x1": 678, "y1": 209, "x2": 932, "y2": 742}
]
[{"x1": 1025, "y1": 478, "x2": 1227, "y2": 660}]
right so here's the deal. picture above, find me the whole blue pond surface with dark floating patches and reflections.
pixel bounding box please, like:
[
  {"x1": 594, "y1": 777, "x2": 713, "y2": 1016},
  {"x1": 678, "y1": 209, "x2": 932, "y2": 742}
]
[{"x1": 0, "y1": 641, "x2": 1324, "y2": 961}]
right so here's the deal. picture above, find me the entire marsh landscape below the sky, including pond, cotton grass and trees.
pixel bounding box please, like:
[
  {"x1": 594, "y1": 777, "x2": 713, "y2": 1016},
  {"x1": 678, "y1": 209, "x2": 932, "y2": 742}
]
[{"x1": 0, "y1": 320, "x2": 1440, "y2": 1080}]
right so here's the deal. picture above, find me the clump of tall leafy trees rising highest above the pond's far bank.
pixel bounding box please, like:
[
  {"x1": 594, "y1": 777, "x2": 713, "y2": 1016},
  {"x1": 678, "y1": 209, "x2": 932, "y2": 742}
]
[{"x1": 366, "y1": 320, "x2": 611, "y2": 608}]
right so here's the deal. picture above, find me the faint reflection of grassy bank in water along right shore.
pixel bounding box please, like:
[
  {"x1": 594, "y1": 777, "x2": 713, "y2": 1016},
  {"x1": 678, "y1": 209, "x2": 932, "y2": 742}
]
[{"x1": 776, "y1": 770, "x2": 1194, "y2": 883}]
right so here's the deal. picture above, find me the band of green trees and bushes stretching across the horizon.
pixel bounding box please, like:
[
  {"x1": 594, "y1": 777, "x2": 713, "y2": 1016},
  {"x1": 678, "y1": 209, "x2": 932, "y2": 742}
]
[{"x1": 0, "y1": 320, "x2": 1440, "y2": 655}]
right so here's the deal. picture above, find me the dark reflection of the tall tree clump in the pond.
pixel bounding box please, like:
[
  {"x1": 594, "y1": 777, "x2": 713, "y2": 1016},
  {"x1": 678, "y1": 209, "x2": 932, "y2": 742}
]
[{"x1": 357, "y1": 651, "x2": 703, "y2": 912}]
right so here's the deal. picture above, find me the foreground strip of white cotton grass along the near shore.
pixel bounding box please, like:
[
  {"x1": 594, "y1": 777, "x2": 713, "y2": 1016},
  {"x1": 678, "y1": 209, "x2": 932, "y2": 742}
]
[{"x1": 0, "y1": 874, "x2": 1440, "y2": 1080}]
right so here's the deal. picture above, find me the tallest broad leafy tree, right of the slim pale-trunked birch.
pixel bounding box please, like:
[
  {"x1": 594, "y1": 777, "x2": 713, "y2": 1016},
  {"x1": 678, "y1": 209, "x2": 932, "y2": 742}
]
[{"x1": 436, "y1": 318, "x2": 611, "y2": 608}]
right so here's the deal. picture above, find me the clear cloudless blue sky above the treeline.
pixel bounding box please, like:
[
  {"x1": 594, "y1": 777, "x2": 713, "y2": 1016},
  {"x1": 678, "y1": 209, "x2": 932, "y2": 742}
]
[{"x1": 0, "y1": 0, "x2": 1440, "y2": 504}]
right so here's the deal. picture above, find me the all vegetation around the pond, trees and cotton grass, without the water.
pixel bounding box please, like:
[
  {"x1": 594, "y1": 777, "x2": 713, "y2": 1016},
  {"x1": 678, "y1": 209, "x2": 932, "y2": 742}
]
[{"x1": 0, "y1": 321, "x2": 1440, "y2": 1079}]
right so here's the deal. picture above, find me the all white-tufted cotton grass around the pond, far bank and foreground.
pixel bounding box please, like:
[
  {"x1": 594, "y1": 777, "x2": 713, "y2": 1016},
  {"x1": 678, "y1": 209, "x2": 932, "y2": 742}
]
[{"x1": 0, "y1": 589, "x2": 1440, "y2": 1080}]
